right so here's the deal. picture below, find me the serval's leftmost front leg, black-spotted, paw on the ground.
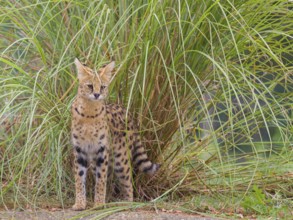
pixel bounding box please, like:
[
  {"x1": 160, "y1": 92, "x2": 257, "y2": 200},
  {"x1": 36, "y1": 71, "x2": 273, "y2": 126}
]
[{"x1": 72, "y1": 146, "x2": 89, "y2": 210}]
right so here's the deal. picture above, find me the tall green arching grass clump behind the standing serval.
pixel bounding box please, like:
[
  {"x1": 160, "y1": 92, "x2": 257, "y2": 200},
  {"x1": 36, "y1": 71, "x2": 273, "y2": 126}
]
[{"x1": 0, "y1": 0, "x2": 293, "y2": 213}]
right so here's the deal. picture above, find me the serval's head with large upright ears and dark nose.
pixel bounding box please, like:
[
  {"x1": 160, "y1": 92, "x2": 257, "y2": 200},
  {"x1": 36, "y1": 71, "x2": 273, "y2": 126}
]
[{"x1": 74, "y1": 58, "x2": 115, "y2": 101}]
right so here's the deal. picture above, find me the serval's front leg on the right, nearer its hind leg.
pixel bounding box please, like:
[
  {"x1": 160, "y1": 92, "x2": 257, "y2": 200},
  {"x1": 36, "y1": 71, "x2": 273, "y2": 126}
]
[{"x1": 93, "y1": 141, "x2": 109, "y2": 206}]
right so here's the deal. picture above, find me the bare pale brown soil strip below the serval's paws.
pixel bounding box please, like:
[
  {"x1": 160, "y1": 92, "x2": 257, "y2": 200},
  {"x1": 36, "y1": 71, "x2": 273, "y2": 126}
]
[{"x1": 0, "y1": 210, "x2": 216, "y2": 220}]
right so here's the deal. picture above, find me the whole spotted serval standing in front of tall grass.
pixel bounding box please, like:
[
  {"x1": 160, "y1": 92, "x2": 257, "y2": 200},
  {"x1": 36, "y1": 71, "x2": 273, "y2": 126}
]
[{"x1": 71, "y1": 59, "x2": 159, "y2": 210}]
